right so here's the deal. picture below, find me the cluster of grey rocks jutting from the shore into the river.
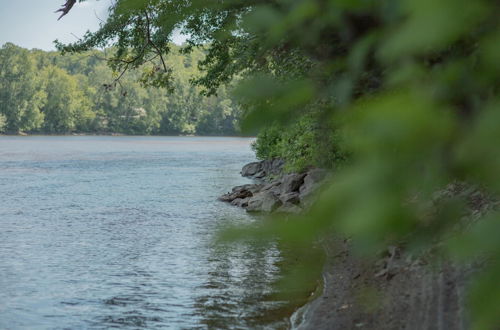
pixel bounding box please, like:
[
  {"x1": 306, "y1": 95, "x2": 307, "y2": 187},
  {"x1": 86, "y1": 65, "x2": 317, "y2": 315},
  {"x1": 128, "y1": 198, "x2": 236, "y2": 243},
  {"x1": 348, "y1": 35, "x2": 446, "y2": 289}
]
[{"x1": 219, "y1": 159, "x2": 327, "y2": 213}]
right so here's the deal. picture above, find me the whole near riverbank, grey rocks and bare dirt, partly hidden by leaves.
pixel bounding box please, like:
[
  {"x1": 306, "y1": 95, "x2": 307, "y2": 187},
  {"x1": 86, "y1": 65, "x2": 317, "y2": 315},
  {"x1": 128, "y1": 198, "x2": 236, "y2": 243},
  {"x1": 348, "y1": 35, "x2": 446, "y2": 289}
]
[{"x1": 221, "y1": 161, "x2": 499, "y2": 330}]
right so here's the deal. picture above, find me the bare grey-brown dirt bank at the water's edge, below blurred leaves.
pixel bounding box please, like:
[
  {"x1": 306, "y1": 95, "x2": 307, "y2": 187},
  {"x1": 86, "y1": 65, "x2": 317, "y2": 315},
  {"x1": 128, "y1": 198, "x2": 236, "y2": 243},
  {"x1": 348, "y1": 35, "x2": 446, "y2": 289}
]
[{"x1": 292, "y1": 240, "x2": 471, "y2": 330}]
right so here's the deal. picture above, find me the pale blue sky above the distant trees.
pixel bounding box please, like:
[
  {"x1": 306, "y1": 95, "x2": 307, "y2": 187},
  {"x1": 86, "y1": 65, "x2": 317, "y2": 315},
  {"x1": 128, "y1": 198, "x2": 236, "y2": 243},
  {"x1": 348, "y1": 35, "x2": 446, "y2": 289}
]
[{"x1": 0, "y1": 0, "x2": 185, "y2": 50}]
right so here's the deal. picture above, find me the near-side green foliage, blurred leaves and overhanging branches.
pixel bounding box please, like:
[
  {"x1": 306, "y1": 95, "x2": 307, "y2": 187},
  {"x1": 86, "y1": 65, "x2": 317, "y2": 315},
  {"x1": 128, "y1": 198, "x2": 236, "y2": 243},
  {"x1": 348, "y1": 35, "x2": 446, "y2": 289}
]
[{"x1": 56, "y1": 0, "x2": 500, "y2": 329}]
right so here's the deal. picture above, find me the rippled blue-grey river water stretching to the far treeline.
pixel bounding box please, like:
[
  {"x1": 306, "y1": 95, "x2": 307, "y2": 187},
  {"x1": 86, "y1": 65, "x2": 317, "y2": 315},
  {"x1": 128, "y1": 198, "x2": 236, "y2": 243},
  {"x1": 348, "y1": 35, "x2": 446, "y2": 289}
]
[{"x1": 0, "y1": 136, "x2": 287, "y2": 329}]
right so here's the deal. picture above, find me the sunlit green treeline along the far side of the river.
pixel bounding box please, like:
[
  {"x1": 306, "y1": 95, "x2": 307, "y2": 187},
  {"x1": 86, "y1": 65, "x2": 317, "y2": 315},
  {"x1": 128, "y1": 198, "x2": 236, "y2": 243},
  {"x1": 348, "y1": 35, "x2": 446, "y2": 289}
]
[{"x1": 0, "y1": 43, "x2": 241, "y2": 135}]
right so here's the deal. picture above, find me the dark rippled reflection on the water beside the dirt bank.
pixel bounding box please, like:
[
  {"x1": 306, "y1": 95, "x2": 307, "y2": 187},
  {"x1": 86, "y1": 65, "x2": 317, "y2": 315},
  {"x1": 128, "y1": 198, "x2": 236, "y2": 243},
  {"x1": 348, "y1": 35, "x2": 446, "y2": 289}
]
[{"x1": 196, "y1": 243, "x2": 286, "y2": 328}]
